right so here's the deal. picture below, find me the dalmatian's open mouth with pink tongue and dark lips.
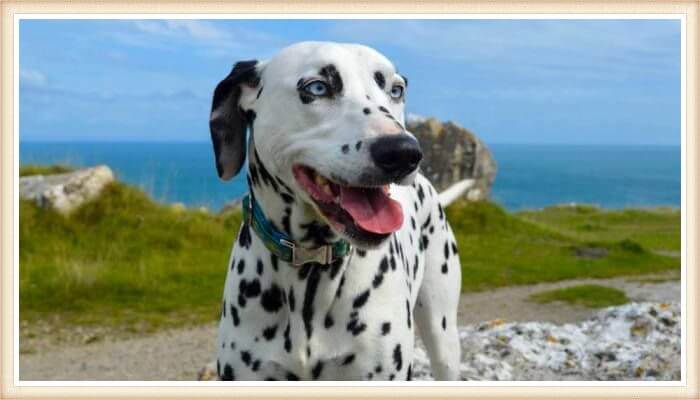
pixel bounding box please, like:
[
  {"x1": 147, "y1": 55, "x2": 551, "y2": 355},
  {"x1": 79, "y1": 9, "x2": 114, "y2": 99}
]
[{"x1": 293, "y1": 165, "x2": 403, "y2": 242}]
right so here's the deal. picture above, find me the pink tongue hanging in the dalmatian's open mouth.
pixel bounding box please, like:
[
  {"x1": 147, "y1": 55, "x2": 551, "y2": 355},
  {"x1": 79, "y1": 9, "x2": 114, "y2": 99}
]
[{"x1": 340, "y1": 186, "x2": 403, "y2": 233}]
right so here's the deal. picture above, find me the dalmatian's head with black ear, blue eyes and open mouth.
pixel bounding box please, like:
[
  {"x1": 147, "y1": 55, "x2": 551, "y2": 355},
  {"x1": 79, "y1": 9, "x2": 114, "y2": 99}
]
[{"x1": 210, "y1": 42, "x2": 422, "y2": 246}]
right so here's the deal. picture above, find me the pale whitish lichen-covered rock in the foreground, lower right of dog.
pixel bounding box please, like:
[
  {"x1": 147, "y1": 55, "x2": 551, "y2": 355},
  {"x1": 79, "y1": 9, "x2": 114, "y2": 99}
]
[{"x1": 413, "y1": 303, "x2": 681, "y2": 381}]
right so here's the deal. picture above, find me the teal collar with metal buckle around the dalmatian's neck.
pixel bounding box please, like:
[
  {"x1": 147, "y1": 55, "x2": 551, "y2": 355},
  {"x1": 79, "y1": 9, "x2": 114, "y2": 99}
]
[{"x1": 243, "y1": 195, "x2": 352, "y2": 267}]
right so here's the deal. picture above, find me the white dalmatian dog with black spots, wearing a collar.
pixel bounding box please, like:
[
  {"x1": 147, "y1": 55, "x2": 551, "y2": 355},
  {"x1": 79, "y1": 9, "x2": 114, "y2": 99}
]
[{"x1": 210, "y1": 42, "x2": 461, "y2": 381}]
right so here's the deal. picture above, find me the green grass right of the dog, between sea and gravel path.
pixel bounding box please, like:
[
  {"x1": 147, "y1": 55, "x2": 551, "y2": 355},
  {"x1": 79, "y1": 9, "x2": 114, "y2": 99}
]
[{"x1": 446, "y1": 202, "x2": 680, "y2": 291}]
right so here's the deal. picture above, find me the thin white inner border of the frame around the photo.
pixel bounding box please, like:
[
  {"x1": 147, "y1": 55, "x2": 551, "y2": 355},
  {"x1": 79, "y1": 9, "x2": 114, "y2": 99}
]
[{"x1": 13, "y1": 13, "x2": 688, "y2": 387}]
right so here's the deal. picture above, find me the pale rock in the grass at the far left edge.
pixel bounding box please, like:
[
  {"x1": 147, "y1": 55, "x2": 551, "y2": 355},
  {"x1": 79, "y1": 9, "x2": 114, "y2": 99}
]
[{"x1": 19, "y1": 165, "x2": 114, "y2": 214}]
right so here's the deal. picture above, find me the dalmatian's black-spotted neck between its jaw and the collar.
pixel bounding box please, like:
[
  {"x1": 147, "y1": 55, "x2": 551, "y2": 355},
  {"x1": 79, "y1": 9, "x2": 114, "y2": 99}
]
[{"x1": 247, "y1": 143, "x2": 340, "y2": 248}]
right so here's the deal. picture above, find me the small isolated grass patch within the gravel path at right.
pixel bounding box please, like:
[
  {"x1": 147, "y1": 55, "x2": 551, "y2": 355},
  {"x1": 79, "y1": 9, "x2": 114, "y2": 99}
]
[{"x1": 530, "y1": 285, "x2": 629, "y2": 308}]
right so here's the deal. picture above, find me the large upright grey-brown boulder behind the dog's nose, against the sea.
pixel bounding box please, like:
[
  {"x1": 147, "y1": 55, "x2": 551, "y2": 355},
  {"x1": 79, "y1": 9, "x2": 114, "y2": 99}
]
[{"x1": 407, "y1": 117, "x2": 497, "y2": 201}]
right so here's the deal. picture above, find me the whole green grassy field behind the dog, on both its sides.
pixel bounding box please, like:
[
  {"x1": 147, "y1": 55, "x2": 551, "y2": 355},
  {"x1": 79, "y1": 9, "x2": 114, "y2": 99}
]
[{"x1": 20, "y1": 167, "x2": 680, "y2": 332}]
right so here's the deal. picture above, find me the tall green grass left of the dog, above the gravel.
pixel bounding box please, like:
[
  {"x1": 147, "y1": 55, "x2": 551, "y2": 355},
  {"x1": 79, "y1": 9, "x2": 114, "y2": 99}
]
[{"x1": 19, "y1": 183, "x2": 240, "y2": 330}]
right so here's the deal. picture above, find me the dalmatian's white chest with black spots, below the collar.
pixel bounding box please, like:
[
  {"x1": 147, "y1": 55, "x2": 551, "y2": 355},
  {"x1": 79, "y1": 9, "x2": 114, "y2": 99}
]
[{"x1": 218, "y1": 232, "x2": 422, "y2": 380}]
